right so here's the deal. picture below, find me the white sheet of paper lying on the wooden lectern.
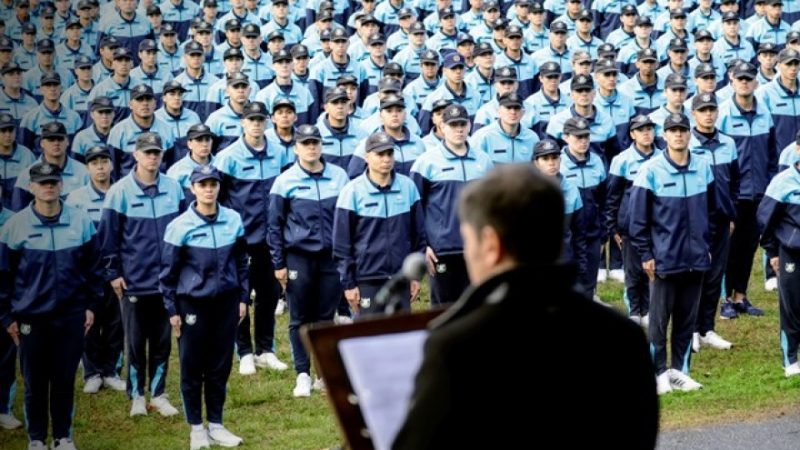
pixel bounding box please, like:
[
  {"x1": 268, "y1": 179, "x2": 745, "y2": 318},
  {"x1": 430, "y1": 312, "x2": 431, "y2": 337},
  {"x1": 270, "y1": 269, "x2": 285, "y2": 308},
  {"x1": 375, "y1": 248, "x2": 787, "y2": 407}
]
[{"x1": 338, "y1": 330, "x2": 428, "y2": 450}]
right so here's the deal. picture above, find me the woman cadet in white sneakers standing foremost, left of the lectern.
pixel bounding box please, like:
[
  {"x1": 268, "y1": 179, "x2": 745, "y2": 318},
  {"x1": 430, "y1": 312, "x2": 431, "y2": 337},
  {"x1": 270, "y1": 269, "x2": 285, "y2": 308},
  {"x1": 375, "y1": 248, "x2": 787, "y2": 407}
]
[{"x1": 160, "y1": 165, "x2": 250, "y2": 449}]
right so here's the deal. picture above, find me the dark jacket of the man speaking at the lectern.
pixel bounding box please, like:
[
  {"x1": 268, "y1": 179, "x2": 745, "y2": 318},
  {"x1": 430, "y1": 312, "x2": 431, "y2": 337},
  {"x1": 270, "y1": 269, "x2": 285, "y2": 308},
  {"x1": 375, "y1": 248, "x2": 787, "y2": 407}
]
[{"x1": 393, "y1": 266, "x2": 658, "y2": 450}]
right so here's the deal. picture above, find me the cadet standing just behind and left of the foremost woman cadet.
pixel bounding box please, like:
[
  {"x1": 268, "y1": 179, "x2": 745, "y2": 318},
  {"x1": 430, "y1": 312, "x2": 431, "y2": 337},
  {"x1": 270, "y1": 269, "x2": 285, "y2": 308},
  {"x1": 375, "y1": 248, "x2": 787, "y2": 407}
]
[{"x1": 100, "y1": 132, "x2": 184, "y2": 416}]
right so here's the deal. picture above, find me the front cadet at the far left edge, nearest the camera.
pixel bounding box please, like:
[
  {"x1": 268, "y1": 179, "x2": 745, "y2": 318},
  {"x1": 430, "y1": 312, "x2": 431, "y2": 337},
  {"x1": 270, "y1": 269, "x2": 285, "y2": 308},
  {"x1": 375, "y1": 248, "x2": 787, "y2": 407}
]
[{"x1": 0, "y1": 162, "x2": 103, "y2": 450}]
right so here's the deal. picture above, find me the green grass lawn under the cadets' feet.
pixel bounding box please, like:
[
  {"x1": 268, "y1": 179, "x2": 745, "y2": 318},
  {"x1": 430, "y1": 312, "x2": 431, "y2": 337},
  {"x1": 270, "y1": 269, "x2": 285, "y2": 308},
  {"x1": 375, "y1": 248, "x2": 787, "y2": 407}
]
[{"x1": 0, "y1": 258, "x2": 800, "y2": 450}]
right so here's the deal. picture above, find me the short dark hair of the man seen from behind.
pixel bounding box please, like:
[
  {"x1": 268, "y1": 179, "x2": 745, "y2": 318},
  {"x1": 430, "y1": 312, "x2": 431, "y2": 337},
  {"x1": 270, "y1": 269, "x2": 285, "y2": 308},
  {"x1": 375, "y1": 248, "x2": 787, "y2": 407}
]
[{"x1": 458, "y1": 164, "x2": 564, "y2": 264}]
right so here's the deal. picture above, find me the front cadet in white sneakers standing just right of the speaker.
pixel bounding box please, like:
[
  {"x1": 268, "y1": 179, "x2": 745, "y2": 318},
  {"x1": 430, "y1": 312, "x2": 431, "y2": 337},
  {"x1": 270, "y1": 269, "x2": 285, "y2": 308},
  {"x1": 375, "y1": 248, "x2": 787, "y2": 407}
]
[{"x1": 630, "y1": 114, "x2": 716, "y2": 394}]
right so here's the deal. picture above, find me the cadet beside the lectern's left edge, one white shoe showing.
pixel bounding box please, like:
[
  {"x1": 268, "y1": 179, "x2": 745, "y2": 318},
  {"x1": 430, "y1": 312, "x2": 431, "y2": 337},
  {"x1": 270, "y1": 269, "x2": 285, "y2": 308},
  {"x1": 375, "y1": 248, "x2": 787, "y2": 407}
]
[{"x1": 267, "y1": 125, "x2": 349, "y2": 397}]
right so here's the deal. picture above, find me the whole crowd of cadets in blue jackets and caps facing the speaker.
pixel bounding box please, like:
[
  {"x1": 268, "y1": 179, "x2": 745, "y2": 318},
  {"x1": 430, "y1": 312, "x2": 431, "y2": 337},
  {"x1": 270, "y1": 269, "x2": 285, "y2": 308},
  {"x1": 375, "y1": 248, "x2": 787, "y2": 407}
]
[{"x1": 0, "y1": 0, "x2": 800, "y2": 450}]
